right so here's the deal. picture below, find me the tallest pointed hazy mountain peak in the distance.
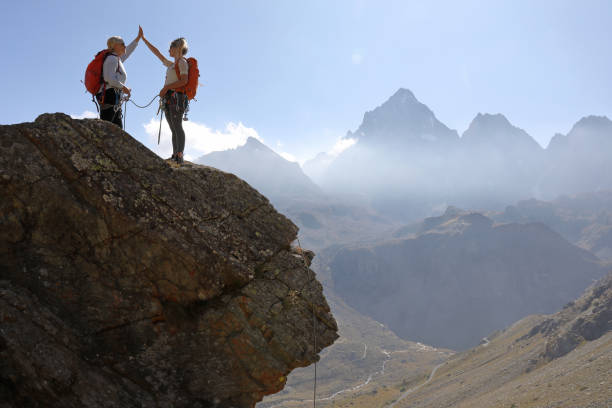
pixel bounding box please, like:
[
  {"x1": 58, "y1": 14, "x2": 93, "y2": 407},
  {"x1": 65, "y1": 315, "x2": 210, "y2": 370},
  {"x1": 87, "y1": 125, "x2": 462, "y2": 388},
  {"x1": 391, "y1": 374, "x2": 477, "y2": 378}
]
[{"x1": 321, "y1": 89, "x2": 459, "y2": 218}]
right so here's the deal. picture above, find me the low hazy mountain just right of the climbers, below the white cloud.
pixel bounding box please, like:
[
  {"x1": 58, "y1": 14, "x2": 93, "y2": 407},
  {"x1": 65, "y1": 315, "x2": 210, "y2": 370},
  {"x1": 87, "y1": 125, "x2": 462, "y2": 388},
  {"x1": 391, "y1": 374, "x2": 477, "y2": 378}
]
[{"x1": 195, "y1": 137, "x2": 323, "y2": 208}]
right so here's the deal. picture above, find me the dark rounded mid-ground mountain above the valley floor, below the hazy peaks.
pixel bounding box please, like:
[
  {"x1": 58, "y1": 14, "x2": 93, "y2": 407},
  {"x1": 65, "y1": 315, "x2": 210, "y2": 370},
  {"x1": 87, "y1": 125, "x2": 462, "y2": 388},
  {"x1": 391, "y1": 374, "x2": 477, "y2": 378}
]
[{"x1": 329, "y1": 210, "x2": 604, "y2": 349}]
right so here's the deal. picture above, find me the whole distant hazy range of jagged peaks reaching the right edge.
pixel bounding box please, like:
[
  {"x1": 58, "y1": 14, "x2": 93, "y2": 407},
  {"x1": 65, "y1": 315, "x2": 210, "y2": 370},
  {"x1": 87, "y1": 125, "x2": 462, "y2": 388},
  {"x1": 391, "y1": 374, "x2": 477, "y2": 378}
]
[{"x1": 305, "y1": 89, "x2": 612, "y2": 220}]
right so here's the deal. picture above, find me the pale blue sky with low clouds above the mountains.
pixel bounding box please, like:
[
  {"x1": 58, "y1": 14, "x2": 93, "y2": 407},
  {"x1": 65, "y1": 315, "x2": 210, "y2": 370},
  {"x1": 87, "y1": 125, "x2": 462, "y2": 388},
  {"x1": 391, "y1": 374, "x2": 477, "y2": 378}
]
[{"x1": 0, "y1": 0, "x2": 612, "y2": 162}]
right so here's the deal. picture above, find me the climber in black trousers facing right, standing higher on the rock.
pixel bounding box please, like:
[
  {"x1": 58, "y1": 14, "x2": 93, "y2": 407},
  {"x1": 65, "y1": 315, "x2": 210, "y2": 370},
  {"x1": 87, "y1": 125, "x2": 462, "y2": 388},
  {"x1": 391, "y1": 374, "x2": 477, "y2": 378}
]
[{"x1": 96, "y1": 27, "x2": 143, "y2": 128}]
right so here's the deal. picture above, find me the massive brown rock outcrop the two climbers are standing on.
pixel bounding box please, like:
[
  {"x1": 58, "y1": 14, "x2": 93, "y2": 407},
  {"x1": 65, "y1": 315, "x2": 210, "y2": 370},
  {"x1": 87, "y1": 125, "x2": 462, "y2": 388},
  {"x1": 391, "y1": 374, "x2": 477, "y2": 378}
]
[{"x1": 0, "y1": 114, "x2": 337, "y2": 407}]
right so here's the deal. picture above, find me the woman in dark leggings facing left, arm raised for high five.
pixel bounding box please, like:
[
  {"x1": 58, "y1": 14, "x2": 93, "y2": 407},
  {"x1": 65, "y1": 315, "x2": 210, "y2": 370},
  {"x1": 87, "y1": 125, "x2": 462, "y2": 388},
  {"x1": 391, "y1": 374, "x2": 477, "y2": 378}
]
[{"x1": 141, "y1": 29, "x2": 189, "y2": 164}]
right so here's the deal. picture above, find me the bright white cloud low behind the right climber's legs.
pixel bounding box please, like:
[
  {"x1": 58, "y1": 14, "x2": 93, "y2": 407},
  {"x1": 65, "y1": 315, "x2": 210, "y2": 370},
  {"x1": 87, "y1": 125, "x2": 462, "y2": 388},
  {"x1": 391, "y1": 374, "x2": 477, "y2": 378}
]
[{"x1": 143, "y1": 118, "x2": 263, "y2": 160}]
